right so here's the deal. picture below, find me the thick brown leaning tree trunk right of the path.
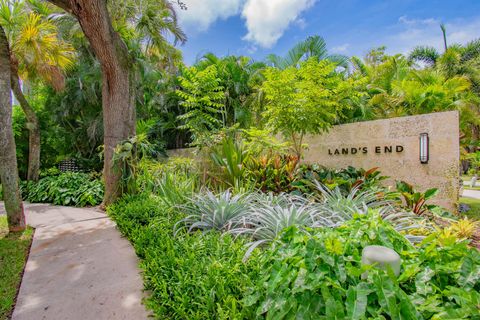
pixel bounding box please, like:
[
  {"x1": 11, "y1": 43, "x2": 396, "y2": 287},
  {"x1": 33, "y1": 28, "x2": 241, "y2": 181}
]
[{"x1": 49, "y1": 0, "x2": 135, "y2": 205}]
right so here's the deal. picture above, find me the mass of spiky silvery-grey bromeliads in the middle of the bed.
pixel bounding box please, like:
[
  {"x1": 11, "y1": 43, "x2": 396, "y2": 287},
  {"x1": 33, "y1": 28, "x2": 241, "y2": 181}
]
[{"x1": 175, "y1": 182, "x2": 433, "y2": 258}]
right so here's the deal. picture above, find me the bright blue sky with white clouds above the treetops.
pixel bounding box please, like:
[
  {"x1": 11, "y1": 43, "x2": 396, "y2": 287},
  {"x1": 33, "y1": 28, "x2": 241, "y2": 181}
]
[{"x1": 174, "y1": 0, "x2": 480, "y2": 64}]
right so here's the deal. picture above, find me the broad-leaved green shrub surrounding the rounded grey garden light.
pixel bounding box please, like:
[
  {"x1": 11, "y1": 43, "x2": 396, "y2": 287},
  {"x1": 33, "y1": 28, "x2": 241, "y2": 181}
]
[{"x1": 245, "y1": 215, "x2": 480, "y2": 319}]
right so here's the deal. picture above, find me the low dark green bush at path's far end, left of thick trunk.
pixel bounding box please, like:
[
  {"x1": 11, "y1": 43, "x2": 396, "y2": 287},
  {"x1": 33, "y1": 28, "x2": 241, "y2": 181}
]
[{"x1": 21, "y1": 170, "x2": 104, "y2": 207}]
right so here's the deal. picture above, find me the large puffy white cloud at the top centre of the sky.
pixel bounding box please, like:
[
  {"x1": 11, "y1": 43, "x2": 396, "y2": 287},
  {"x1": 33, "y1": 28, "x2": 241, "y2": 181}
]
[{"x1": 242, "y1": 0, "x2": 316, "y2": 48}]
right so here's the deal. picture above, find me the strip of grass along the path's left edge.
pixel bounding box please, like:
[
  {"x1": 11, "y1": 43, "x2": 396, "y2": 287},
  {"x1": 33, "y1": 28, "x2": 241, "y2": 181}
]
[{"x1": 0, "y1": 216, "x2": 33, "y2": 320}]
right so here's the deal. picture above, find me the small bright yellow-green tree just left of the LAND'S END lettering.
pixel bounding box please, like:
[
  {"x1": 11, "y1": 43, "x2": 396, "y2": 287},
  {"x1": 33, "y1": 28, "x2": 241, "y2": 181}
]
[{"x1": 262, "y1": 58, "x2": 353, "y2": 157}]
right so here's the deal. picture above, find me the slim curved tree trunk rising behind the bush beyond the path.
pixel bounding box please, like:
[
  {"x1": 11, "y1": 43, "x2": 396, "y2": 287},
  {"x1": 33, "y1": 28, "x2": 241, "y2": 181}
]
[{"x1": 10, "y1": 63, "x2": 40, "y2": 181}]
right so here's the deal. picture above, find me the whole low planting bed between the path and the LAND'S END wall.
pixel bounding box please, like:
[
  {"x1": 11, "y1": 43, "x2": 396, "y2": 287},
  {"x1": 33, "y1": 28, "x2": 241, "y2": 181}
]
[{"x1": 108, "y1": 156, "x2": 480, "y2": 319}]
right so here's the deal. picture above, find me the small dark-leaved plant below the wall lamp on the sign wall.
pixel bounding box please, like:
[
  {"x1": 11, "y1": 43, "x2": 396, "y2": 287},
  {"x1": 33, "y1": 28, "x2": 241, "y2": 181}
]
[{"x1": 397, "y1": 181, "x2": 438, "y2": 215}]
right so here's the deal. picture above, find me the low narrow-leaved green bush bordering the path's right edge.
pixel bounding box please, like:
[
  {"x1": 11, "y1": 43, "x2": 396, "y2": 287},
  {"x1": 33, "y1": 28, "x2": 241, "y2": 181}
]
[{"x1": 108, "y1": 194, "x2": 259, "y2": 319}]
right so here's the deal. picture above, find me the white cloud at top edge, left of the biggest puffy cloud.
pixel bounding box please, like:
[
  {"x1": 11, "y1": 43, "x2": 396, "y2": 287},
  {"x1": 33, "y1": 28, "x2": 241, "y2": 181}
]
[{"x1": 177, "y1": 0, "x2": 244, "y2": 31}]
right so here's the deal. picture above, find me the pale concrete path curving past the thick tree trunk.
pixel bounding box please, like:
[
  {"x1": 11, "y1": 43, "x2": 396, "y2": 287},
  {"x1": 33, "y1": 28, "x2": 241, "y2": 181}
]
[{"x1": 0, "y1": 203, "x2": 147, "y2": 320}]
